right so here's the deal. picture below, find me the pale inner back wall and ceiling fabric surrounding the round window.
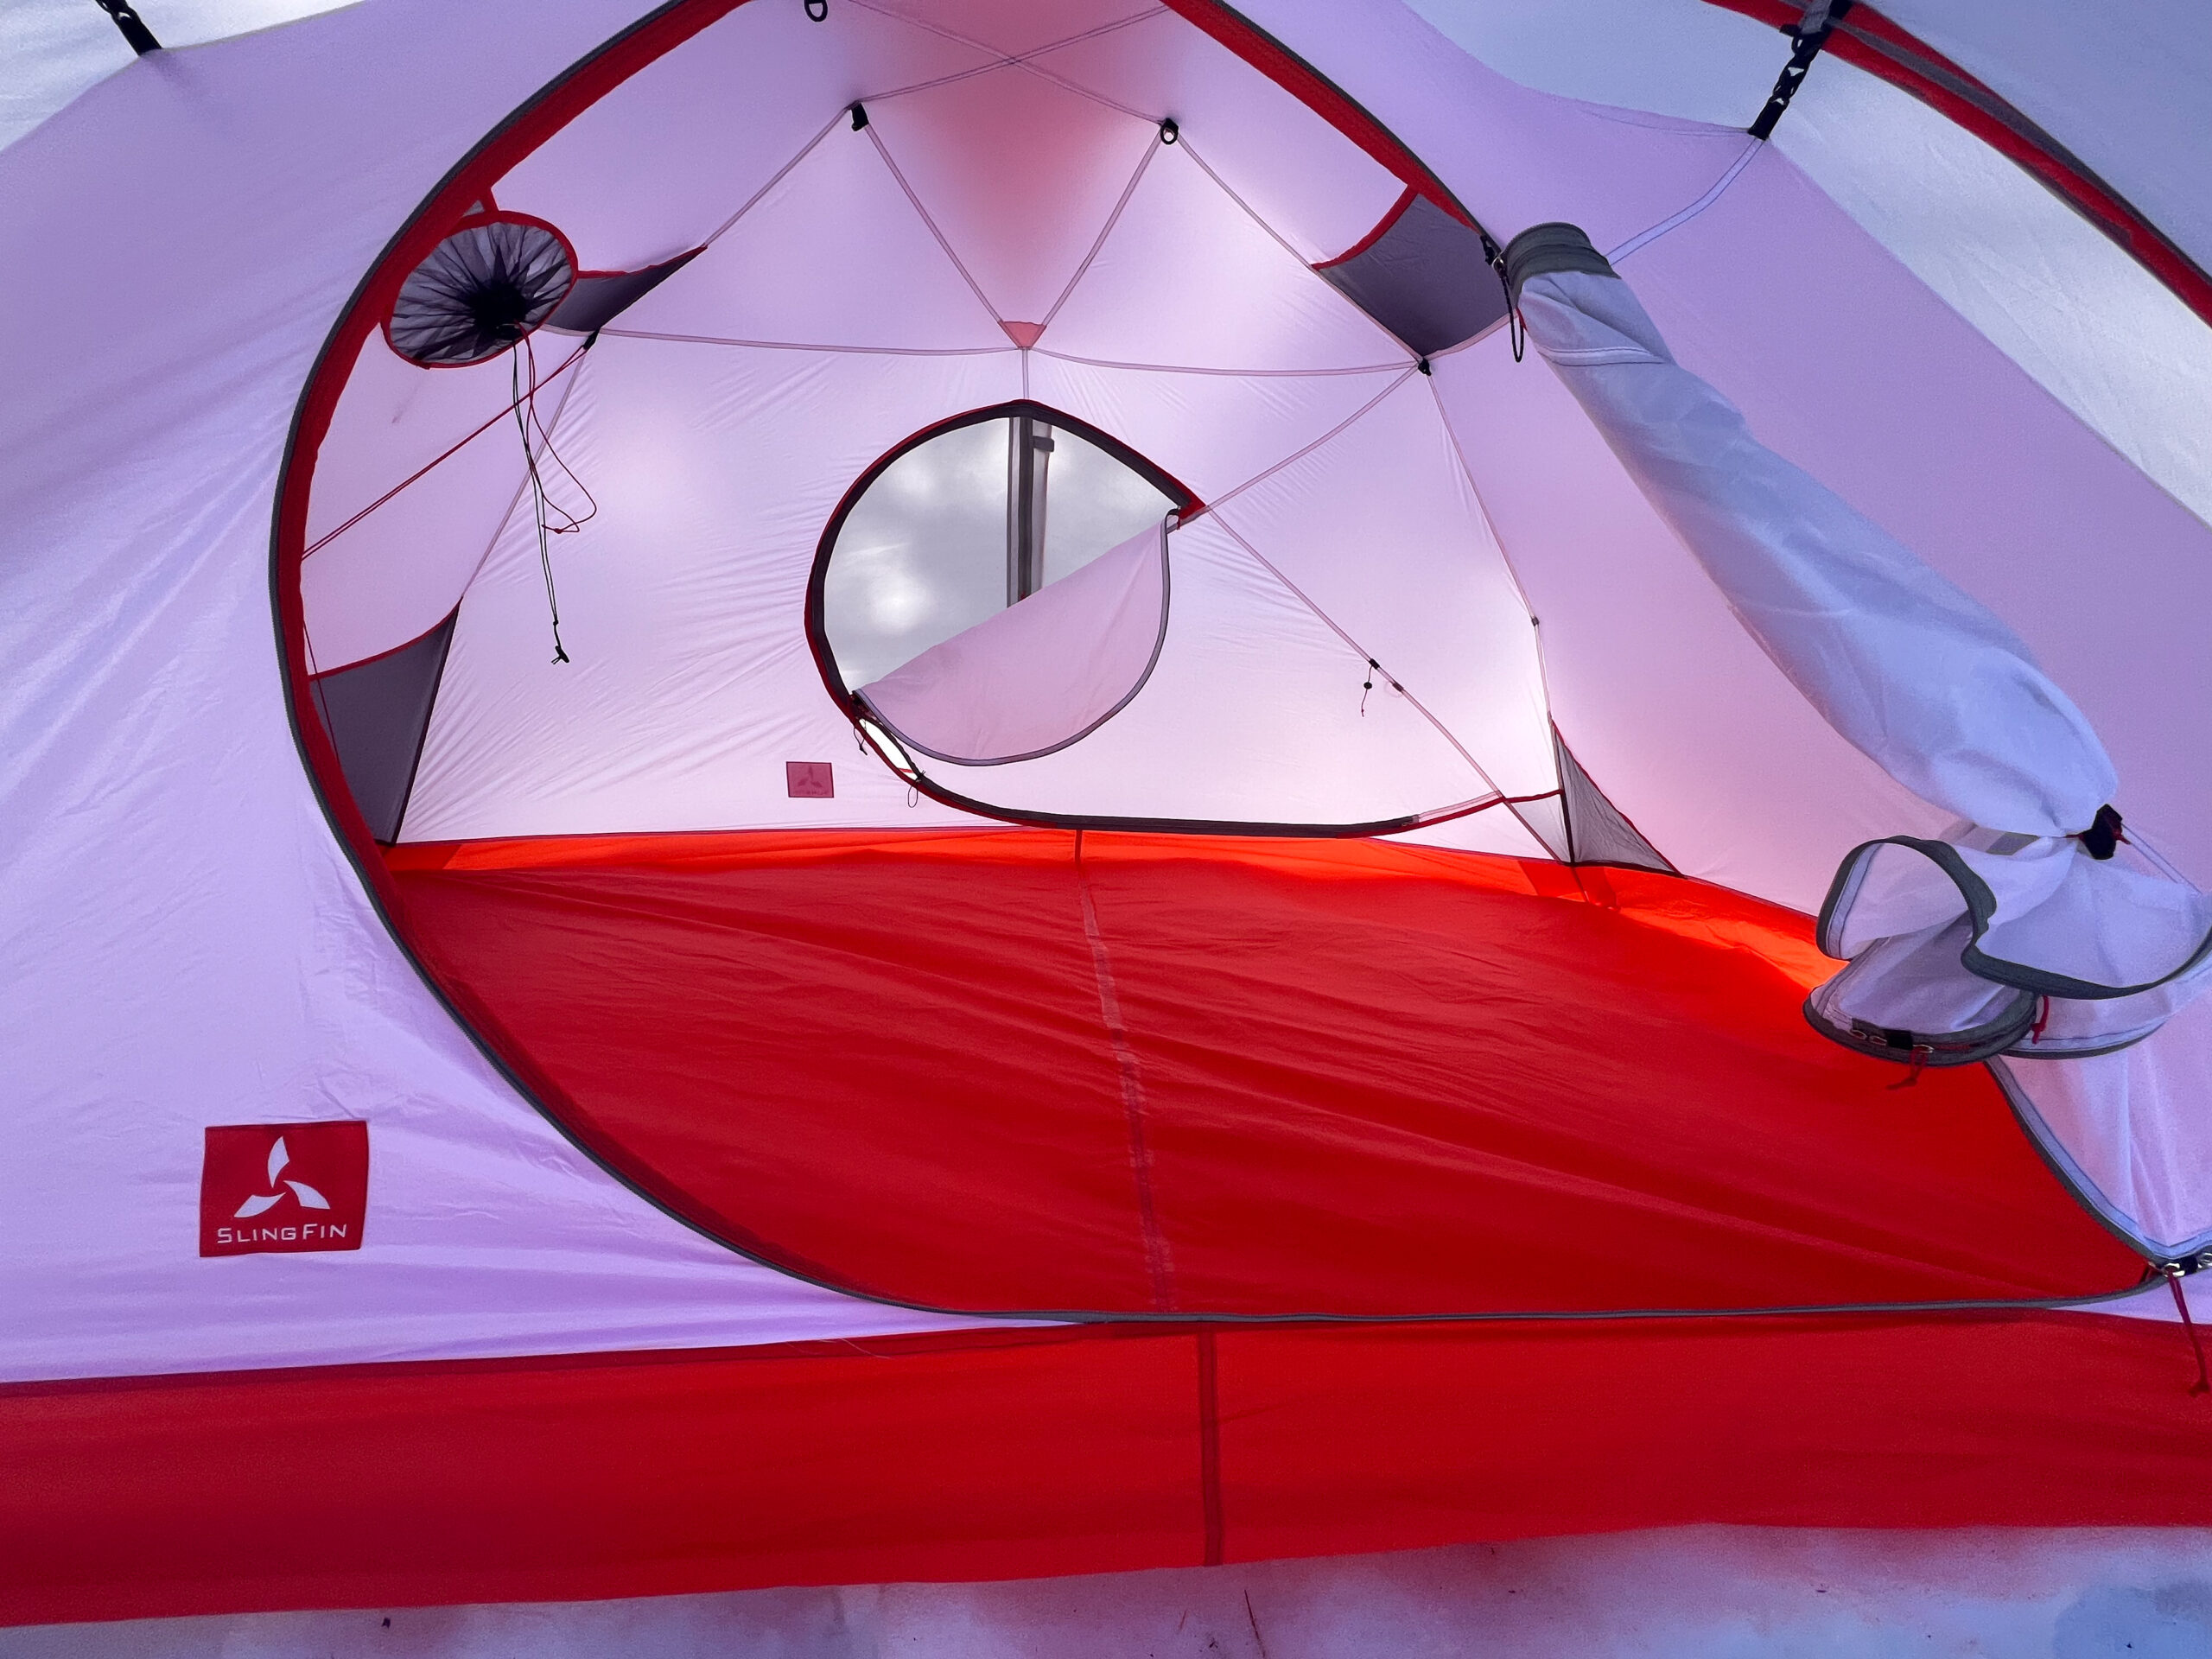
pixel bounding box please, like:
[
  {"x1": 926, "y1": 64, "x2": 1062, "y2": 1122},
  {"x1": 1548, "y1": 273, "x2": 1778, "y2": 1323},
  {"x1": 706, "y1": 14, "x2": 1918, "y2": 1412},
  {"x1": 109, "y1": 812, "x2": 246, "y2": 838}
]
[{"x1": 362, "y1": 4, "x2": 1557, "y2": 845}]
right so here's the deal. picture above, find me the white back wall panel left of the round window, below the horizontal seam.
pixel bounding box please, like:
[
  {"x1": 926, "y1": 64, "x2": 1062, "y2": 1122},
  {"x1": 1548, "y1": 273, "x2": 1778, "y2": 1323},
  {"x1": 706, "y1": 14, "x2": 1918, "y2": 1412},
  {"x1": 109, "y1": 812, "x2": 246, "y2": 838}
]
[{"x1": 402, "y1": 338, "x2": 1020, "y2": 841}]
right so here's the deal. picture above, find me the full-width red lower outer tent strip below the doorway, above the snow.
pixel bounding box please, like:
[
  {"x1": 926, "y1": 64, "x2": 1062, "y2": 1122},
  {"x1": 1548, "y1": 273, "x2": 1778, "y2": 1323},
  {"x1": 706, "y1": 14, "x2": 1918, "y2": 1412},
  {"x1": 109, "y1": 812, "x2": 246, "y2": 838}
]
[{"x1": 0, "y1": 1314, "x2": 2212, "y2": 1624}]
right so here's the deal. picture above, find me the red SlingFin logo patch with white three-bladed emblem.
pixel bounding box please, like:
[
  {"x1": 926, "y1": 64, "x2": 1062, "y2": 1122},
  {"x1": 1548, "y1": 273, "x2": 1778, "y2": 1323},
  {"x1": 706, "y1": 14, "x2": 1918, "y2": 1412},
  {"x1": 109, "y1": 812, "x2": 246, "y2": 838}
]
[{"x1": 199, "y1": 1117, "x2": 370, "y2": 1256}]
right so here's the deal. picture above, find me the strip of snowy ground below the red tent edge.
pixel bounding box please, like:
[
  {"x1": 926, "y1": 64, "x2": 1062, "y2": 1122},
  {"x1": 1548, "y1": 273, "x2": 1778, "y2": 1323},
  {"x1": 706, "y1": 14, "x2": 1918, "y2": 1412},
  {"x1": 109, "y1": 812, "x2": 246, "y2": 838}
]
[{"x1": 0, "y1": 1526, "x2": 2212, "y2": 1659}]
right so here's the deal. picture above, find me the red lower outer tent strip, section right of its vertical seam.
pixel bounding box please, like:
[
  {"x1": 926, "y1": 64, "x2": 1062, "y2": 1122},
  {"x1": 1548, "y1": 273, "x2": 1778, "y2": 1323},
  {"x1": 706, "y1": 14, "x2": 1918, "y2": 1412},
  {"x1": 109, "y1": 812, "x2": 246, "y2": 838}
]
[{"x1": 1219, "y1": 1314, "x2": 2212, "y2": 1560}]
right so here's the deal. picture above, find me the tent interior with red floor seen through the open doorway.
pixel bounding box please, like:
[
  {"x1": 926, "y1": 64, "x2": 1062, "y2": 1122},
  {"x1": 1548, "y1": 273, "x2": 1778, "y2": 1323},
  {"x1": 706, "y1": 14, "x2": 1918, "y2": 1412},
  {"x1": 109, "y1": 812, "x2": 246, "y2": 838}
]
[{"x1": 279, "y1": 0, "x2": 2144, "y2": 1316}]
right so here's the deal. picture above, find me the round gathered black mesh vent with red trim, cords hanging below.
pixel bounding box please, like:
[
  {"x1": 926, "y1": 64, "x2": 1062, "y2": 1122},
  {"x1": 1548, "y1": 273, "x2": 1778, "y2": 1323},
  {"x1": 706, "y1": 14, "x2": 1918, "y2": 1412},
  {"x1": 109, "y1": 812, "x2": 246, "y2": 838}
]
[{"x1": 385, "y1": 217, "x2": 575, "y2": 367}]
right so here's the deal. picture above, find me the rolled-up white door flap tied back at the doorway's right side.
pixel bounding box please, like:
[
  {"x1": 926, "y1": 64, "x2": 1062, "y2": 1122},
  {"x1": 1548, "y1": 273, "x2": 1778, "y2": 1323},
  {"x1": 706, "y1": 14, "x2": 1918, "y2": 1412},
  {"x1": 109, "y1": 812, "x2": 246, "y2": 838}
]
[{"x1": 1506, "y1": 226, "x2": 2212, "y2": 1256}]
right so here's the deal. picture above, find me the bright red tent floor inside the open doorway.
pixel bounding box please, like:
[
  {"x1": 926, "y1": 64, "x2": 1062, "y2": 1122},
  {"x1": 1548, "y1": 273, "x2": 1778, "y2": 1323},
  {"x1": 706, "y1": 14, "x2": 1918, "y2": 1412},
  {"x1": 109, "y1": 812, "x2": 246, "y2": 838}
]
[{"x1": 394, "y1": 832, "x2": 2141, "y2": 1314}]
